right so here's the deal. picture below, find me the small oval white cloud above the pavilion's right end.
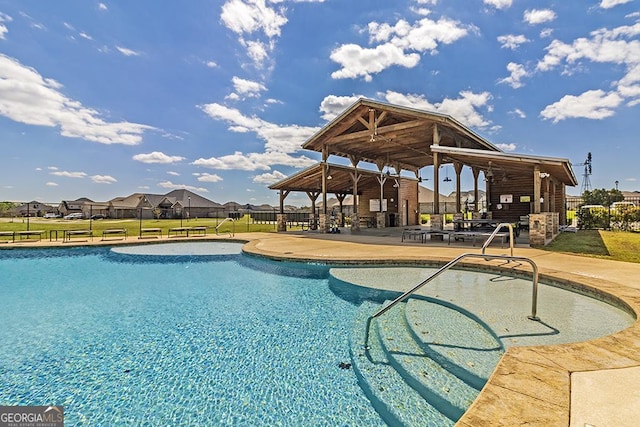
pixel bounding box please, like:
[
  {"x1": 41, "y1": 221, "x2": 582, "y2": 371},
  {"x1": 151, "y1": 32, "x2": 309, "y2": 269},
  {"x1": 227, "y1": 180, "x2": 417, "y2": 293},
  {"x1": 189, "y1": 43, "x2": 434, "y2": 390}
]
[{"x1": 540, "y1": 90, "x2": 623, "y2": 123}]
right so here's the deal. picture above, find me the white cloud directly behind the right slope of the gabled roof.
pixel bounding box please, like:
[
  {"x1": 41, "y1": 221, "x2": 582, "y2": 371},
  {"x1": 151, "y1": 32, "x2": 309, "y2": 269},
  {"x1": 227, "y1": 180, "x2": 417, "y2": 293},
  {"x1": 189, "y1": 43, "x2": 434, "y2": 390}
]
[{"x1": 383, "y1": 91, "x2": 492, "y2": 129}]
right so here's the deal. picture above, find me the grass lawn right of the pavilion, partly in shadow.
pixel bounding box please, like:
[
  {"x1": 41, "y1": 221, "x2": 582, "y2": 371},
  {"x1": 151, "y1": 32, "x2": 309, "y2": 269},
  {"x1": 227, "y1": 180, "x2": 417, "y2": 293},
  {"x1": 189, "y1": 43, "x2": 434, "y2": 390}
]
[{"x1": 543, "y1": 230, "x2": 640, "y2": 262}]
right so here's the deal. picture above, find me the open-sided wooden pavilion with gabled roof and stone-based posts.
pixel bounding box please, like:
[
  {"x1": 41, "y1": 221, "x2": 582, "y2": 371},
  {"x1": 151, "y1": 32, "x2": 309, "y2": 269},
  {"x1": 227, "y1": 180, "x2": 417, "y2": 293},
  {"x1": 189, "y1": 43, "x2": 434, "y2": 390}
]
[{"x1": 269, "y1": 99, "x2": 577, "y2": 244}]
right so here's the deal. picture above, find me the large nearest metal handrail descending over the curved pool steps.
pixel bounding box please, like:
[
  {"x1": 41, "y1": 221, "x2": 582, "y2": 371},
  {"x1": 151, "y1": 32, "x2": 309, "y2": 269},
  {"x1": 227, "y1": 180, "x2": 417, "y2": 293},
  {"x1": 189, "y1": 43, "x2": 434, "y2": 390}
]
[{"x1": 364, "y1": 252, "x2": 540, "y2": 351}]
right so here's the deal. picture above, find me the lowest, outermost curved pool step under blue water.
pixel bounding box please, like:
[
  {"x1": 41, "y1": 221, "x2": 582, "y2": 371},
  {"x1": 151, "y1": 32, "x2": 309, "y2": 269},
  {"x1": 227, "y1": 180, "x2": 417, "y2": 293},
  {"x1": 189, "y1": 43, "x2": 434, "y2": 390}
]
[{"x1": 350, "y1": 302, "x2": 454, "y2": 427}]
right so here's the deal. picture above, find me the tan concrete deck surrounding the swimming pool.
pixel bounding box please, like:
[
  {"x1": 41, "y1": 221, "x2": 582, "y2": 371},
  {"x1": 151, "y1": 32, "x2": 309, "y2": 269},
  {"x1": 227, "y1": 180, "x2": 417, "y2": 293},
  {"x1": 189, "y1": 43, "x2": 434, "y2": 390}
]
[{"x1": 2, "y1": 230, "x2": 640, "y2": 427}]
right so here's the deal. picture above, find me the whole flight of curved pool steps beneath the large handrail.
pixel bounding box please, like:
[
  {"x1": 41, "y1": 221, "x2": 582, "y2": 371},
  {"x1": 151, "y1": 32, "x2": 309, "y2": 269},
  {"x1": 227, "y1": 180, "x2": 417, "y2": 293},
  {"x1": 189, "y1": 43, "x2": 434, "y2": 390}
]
[{"x1": 350, "y1": 298, "x2": 503, "y2": 426}]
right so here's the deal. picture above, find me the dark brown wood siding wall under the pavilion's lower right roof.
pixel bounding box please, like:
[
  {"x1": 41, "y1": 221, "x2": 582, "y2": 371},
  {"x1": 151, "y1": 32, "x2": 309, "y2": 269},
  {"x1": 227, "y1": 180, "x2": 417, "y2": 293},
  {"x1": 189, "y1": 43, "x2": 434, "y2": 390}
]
[{"x1": 488, "y1": 173, "x2": 533, "y2": 222}]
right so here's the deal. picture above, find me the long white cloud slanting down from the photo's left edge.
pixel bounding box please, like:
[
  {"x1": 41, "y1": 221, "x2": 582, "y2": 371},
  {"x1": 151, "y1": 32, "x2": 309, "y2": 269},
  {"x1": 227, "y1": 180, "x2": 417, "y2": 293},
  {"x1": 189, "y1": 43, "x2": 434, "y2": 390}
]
[{"x1": 0, "y1": 54, "x2": 154, "y2": 145}]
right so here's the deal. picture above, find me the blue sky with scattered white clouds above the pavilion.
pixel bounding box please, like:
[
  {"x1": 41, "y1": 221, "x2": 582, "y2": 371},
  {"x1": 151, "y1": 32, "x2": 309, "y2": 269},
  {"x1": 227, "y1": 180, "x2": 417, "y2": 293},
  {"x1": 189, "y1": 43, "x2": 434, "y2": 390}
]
[{"x1": 0, "y1": 0, "x2": 640, "y2": 205}]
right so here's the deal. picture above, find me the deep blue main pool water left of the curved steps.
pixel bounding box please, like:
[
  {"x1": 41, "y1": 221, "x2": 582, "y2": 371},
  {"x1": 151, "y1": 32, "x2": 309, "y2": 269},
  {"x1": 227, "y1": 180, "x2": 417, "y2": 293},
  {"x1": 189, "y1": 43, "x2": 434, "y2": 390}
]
[{"x1": 0, "y1": 242, "x2": 632, "y2": 426}]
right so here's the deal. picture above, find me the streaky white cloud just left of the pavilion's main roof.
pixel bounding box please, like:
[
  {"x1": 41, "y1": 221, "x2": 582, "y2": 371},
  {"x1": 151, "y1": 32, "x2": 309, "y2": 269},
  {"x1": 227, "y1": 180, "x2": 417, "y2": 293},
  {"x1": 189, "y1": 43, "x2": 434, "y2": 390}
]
[{"x1": 192, "y1": 103, "x2": 318, "y2": 170}]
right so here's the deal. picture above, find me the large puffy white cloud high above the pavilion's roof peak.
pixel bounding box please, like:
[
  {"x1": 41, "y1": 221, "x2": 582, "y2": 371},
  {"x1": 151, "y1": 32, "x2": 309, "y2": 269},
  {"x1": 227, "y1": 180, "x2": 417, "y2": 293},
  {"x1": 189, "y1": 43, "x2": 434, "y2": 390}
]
[{"x1": 330, "y1": 18, "x2": 469, "y2": 81}]
